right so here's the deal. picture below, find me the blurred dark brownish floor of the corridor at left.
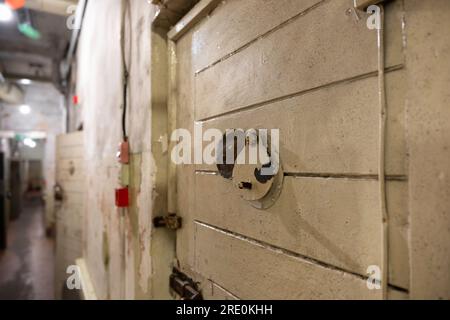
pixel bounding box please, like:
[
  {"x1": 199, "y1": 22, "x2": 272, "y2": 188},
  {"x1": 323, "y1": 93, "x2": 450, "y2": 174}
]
[{"x1": 0, "y1": 199, "x2": 55, "y2": 300}]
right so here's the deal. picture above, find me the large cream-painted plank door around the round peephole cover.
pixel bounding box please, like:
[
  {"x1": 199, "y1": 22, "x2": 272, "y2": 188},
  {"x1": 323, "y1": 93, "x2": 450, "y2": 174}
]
[{"x1": 169, "y1": 0, "x2": 409, "y2": 299}]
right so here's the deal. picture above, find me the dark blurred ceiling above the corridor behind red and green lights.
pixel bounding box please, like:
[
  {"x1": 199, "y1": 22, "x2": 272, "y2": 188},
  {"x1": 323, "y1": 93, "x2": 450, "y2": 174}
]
[{"x1": 0, "y1": 0, "x2": 77, "y2": 85}]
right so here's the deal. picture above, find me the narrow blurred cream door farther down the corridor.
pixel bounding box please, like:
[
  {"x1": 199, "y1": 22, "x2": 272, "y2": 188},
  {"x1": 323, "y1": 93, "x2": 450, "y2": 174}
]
[{"x1": 54, "y1": 132, "x2": 85, "y2": 299}]
